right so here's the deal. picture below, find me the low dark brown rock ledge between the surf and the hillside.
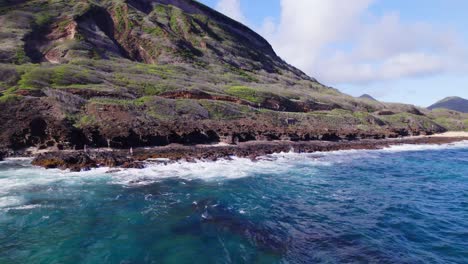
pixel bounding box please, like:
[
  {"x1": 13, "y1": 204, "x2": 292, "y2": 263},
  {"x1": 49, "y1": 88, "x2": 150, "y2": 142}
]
[{"x1": 29, "y1": 136, "x2": 468, "y2": 171}]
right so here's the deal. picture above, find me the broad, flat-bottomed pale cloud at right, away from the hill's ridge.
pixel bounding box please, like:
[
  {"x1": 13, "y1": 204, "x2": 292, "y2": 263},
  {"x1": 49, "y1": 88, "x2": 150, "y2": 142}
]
[{"x1": 314, "y1": 10, "x2": 466, "y2": 83}]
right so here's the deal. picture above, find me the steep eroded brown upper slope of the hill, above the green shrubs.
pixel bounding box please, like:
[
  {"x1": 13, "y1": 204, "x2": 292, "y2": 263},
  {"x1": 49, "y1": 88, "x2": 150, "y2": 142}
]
[{"x1": 0, "y1": 0, "x2": 308, "y2": 79}]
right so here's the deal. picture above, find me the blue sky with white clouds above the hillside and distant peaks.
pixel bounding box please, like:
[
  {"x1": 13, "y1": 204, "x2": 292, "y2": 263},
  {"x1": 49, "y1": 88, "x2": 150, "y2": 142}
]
[{"x1": 201, "y1": 0, "x2": 468, "y2": 106}]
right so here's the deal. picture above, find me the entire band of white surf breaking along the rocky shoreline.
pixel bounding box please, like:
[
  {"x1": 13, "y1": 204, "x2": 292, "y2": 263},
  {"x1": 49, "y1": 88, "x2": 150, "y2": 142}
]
[{"x1": 0, "y1": 141, "x2": 468, "y2": 196}]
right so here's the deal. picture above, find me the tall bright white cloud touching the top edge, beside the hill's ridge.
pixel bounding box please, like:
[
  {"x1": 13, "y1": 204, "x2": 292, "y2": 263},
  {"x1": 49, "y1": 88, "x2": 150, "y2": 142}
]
[{"x1": 266, "y1": 0, "x2": 371, "y2": 70}]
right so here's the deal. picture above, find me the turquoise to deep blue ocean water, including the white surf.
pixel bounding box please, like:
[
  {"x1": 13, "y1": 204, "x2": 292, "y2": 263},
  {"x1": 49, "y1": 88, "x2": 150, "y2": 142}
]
[{"x1": 0, "y1": 143, "x2": 468, "y2": 263}]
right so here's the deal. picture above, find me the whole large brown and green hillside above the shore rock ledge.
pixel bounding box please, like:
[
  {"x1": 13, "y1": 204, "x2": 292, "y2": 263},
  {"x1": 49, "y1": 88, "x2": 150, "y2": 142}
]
[{"x1": 0, "y1": 0, "x2": 460, "y2": 149}]
